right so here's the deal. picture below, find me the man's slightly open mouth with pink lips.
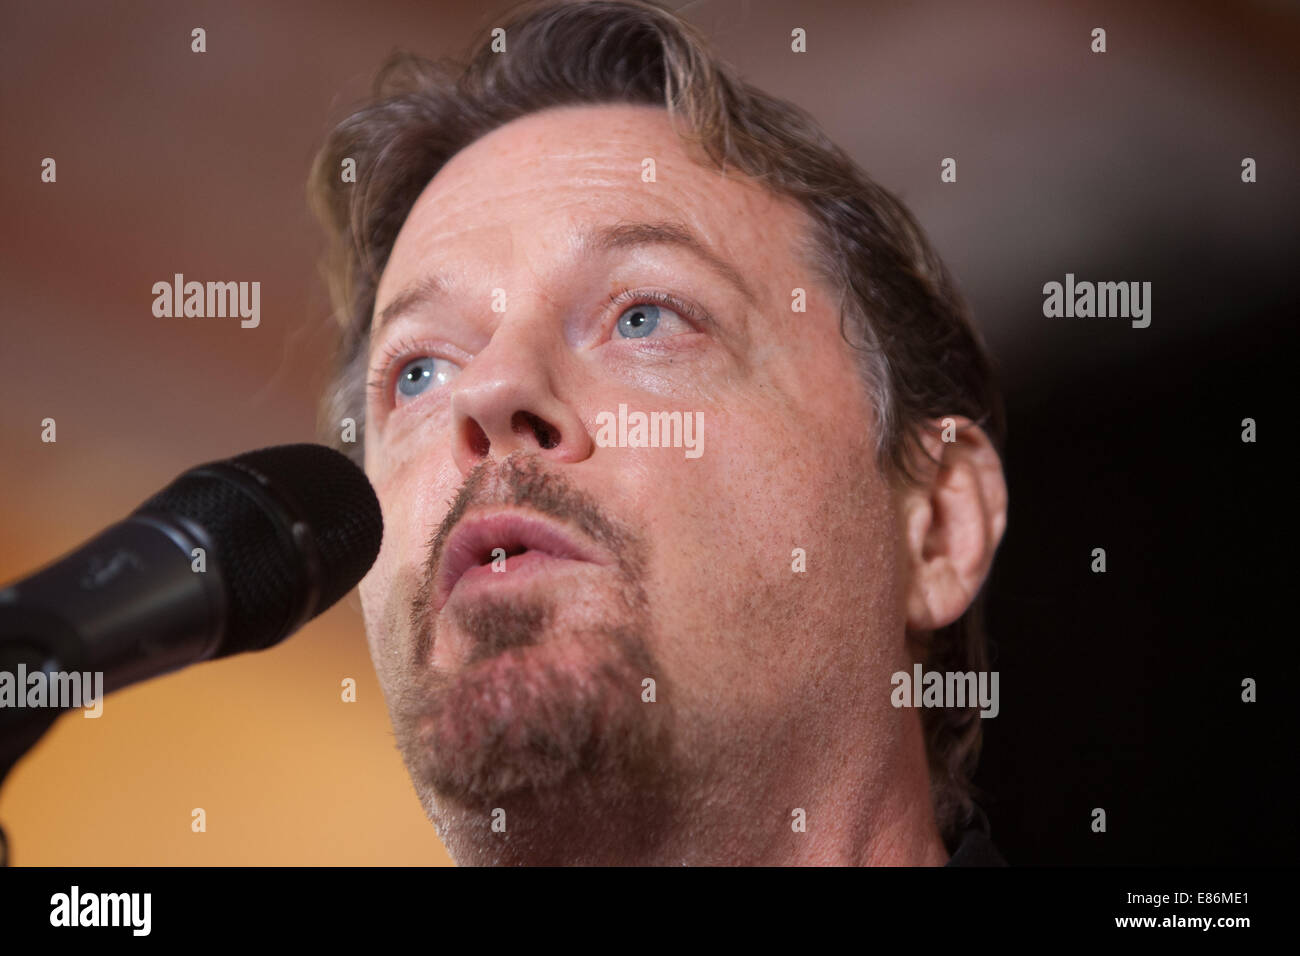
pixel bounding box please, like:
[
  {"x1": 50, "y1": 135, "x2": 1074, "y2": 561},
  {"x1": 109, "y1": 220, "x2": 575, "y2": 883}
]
[{"x1": 434, "y1": 511, "x2": 610, "y2": 611}]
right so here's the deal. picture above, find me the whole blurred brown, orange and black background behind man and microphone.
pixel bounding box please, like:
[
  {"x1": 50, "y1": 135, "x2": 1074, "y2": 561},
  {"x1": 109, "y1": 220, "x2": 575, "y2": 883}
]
[{"x1": 0, "y1": 0, "x2": 1300, "y2": 865}]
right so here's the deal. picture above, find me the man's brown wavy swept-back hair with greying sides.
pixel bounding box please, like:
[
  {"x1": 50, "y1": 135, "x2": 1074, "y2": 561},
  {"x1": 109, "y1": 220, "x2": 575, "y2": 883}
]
[{"x1": 309, "y1": 0, "x2": 1005, "y2": 840}]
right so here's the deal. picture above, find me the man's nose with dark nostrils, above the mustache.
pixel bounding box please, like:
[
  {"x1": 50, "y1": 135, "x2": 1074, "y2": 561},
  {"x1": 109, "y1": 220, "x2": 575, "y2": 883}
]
[{"x1": 451, "y1": 325, "x2": 594, "y2": 475}]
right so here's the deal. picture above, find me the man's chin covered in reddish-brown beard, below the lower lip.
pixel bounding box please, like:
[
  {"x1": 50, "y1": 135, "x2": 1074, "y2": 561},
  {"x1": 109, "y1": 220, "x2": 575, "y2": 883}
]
[{"x1": 394, "y1": 609, "x2": 663, "y2": 818}]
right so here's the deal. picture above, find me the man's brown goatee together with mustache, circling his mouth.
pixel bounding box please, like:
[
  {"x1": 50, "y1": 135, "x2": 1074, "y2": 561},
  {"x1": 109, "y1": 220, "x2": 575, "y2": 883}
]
[{"x1": 390, "y1": 457, "x2": 671, "y2": 816}]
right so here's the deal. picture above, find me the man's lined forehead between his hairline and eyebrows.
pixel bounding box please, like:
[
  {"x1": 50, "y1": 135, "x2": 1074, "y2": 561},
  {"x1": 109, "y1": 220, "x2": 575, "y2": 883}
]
[{"x1": 376, "y1": 104, "x2": 807, "y2": 306}]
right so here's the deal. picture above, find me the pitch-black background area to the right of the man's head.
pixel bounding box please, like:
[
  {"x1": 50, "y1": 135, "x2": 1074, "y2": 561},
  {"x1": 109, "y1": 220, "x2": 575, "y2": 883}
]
[{"x1": 976, "y1": 251, "x2": 1297, "y2": 865}]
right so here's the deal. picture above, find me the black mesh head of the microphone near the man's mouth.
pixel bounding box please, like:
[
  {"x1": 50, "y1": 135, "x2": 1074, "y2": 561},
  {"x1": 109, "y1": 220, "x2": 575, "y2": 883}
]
[{"x1": 138, "y1": 444, "x2": 384, "y2": 657}]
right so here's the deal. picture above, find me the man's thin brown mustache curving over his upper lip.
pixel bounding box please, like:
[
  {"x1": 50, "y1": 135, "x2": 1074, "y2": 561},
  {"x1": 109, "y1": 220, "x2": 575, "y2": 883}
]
[{"x1": 411, "y1": 451, "x2": 645, "y2": 661}]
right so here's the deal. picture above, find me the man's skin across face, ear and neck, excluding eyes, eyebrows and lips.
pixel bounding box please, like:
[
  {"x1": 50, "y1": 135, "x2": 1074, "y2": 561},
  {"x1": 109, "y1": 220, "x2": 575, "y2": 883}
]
[{"x1": 361, "y1": 105, "x2": 1006, "y2": 865}]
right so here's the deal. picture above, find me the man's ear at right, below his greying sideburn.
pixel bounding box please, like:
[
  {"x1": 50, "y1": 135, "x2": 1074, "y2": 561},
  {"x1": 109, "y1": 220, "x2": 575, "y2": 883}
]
[{"x1": 897, "y1": 416, "x2": 1006, "y2": 632}]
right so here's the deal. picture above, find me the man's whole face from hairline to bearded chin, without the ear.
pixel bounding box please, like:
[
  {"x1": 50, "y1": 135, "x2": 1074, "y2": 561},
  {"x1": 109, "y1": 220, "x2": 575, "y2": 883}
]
[{"x1": 361, "y1": 105, "x2": 904, "y2": 855}]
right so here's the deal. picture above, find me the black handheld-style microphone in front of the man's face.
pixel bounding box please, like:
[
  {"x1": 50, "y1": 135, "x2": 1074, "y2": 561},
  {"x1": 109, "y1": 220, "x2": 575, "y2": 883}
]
[{"x1": 0, "y1": 445, "x2": 384, "y2": 764}]
